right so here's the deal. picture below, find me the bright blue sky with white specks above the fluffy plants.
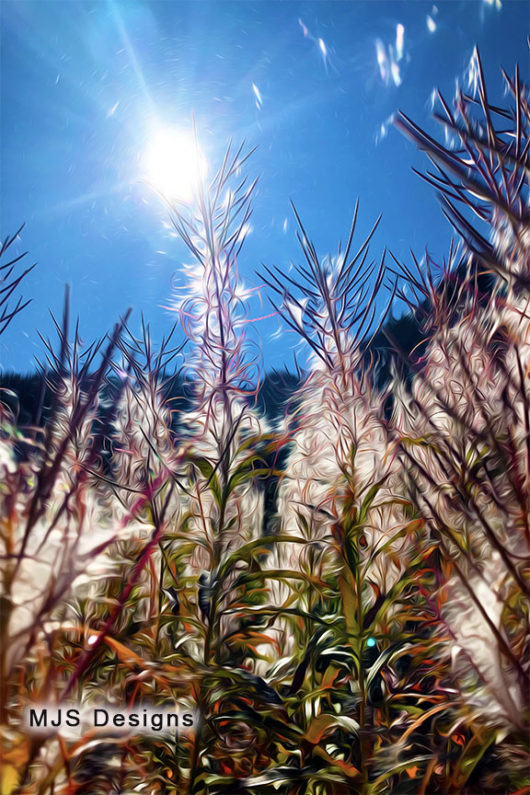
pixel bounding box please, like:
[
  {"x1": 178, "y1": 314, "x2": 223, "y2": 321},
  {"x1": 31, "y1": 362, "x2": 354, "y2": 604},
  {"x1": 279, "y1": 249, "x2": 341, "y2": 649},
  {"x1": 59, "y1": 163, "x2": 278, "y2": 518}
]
[{"x1": 0, "y1": 0, "x2": 529, "y2": 372}]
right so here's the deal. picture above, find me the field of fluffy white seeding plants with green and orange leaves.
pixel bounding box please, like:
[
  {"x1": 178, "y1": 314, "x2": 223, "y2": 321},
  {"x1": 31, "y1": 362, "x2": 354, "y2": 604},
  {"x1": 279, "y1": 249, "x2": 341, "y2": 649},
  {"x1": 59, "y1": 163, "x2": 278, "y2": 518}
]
[{"x1": 0, "y1": 53, "x2": 530, "y2": 795}]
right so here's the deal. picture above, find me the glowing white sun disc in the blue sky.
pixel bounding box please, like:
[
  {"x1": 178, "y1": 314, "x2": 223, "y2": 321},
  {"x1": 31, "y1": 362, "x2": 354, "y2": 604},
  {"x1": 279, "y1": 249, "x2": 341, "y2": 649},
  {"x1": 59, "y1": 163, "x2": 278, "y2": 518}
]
[{"x1": 142, "y1": 127, "x2": 207, "y2": 202}]
